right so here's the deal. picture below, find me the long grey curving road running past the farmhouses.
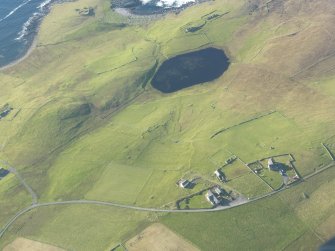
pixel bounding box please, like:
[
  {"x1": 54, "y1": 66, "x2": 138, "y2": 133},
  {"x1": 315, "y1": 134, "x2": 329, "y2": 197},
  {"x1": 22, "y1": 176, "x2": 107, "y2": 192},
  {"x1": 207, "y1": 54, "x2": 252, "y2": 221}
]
[{"x1": 0, "y1": 162, "x2": 335, "y2": 239}]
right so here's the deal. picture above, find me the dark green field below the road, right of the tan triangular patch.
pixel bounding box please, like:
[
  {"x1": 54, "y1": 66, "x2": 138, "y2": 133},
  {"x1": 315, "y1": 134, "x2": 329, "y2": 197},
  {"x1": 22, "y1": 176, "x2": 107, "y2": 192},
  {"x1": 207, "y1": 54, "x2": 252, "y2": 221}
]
[{"x1": 162, "y1": 194, "x2": 306, "y2": 250}]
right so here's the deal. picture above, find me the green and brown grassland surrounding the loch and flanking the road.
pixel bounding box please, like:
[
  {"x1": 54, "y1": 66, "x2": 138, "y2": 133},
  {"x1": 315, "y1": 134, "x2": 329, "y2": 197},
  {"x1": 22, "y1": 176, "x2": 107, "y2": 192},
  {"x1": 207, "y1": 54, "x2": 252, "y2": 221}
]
[{"x1": 0, "y1": 0, "x2": 335, "y2": 250}]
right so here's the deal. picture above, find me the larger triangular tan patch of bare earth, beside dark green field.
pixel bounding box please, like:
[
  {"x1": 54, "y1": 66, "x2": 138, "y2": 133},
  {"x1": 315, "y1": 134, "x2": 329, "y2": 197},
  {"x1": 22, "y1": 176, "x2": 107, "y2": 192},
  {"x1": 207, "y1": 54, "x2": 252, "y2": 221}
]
[{"x1": 126, "y1": 223, "x2": 199, "y2": 251}]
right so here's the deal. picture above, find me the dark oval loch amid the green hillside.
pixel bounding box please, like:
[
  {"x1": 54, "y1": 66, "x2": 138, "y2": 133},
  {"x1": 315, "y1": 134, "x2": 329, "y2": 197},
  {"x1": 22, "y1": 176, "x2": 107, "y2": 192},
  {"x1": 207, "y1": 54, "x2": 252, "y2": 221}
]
[{"x1": 151, "y1": 48, "x2": 230, "y2": 93}]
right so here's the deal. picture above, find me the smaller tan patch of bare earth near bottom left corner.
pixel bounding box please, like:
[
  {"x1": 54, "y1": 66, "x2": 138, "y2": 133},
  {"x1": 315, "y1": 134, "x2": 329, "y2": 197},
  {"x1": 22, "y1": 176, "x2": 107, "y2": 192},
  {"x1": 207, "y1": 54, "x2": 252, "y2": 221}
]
[{"x1": 3, "y1": 238, "x2": 64, "y2": 251}]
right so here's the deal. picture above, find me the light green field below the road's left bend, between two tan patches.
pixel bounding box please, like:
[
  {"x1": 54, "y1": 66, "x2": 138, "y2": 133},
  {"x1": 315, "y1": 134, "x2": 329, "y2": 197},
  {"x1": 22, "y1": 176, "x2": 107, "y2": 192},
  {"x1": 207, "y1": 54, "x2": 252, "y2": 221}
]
[{"x1": 0, "y1": 205, "x2": 150, "y2": 251}]
